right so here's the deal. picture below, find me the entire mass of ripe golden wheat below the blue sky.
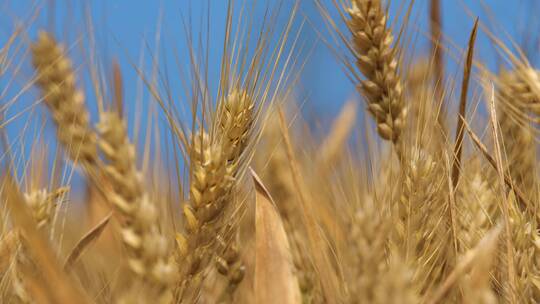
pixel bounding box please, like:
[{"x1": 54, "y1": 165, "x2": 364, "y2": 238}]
[{"x1": 0, "y1": 0, "x2": 540, "y2": 304}]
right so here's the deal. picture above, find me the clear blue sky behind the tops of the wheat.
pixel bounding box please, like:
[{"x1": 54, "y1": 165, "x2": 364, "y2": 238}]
[{"x1": 0, "y1": 0, "x2": 540, "y2": 117}]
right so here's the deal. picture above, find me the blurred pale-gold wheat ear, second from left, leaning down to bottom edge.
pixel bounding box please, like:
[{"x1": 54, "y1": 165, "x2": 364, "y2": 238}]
[{"x1": 97, "y1": 112, "x2": 177, "y2": 303}]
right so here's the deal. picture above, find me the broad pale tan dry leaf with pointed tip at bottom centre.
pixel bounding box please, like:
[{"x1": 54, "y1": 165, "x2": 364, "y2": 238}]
[{"x1": 251, "y1": 170, "x2": 301, "y2": 304}]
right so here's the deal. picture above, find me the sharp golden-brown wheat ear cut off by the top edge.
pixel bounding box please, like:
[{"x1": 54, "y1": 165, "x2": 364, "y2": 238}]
[{"x1": 347, "y1": 0, "x2": 407, "y2": 142}]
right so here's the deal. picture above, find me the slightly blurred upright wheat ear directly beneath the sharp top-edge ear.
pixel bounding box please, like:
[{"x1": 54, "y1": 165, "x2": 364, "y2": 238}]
[{"x1": 397, "y1": 148, "x2": 450, "y2": 294}]
